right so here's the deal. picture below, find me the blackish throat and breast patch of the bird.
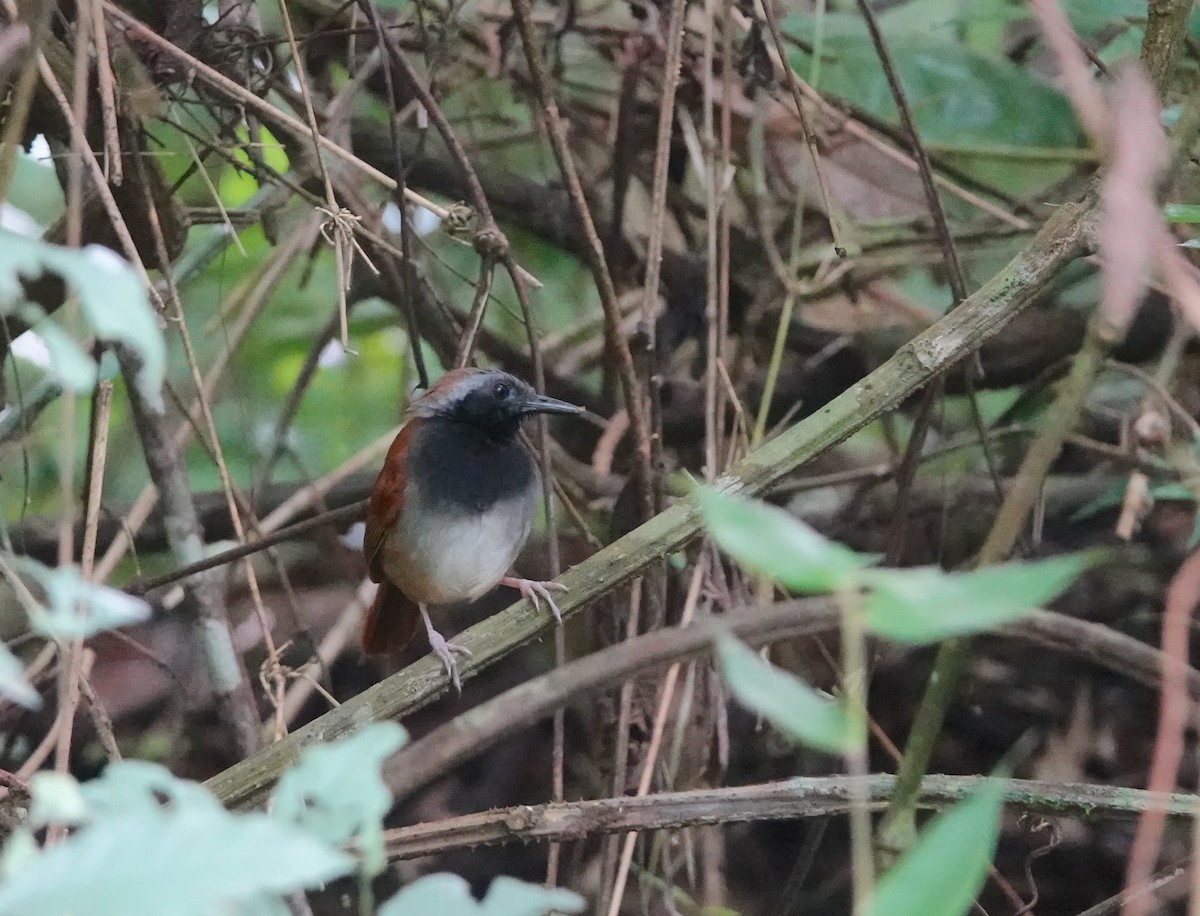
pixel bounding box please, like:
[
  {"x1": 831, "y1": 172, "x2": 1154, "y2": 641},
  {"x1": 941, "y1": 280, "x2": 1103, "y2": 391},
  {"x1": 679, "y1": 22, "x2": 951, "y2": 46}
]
[{"x1": 408, "y1": 417, "x2": 536, "y2": 513}]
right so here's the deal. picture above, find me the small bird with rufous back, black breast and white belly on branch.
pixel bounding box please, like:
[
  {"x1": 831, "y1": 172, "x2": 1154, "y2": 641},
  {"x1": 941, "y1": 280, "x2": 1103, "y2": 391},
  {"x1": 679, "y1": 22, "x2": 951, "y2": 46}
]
[{"x1": 362, "y1": 367, "x2": 583, "y2": 693}]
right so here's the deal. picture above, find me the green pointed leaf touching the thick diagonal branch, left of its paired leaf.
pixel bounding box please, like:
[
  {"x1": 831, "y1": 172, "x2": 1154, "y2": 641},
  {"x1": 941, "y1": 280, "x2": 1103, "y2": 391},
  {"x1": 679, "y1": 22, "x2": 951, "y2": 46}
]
[{"x1": 696, "y1": 489, "x2": 871, "y2": 593}]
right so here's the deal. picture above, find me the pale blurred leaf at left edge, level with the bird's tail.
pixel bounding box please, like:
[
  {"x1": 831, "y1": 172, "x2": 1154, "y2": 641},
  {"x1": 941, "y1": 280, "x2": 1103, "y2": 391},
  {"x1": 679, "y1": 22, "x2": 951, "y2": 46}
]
[{"x1": 8, "y1": 557, "x2": 150, "y2": 640}]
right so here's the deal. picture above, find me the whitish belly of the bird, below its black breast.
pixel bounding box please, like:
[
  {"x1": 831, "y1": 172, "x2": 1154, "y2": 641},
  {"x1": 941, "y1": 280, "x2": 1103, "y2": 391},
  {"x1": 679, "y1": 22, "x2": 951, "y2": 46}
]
[{"x1": 384, "y1": 495, "x2": 534, "y2": 604}]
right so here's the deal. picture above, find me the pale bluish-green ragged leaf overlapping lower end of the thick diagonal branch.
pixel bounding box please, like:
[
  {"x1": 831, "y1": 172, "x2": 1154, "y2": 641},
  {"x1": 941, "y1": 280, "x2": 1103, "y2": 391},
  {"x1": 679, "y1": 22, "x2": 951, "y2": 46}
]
[{"x1": 272, "y1": 722, "x2": 408, "y2": 876}]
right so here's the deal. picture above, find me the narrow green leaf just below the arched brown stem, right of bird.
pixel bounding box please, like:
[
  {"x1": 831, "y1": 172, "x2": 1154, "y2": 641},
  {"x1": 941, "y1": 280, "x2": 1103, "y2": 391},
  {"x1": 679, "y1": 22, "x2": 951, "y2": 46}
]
[{"x1": 716, "y1": 636, "x2": 854, "y2": 754}]
